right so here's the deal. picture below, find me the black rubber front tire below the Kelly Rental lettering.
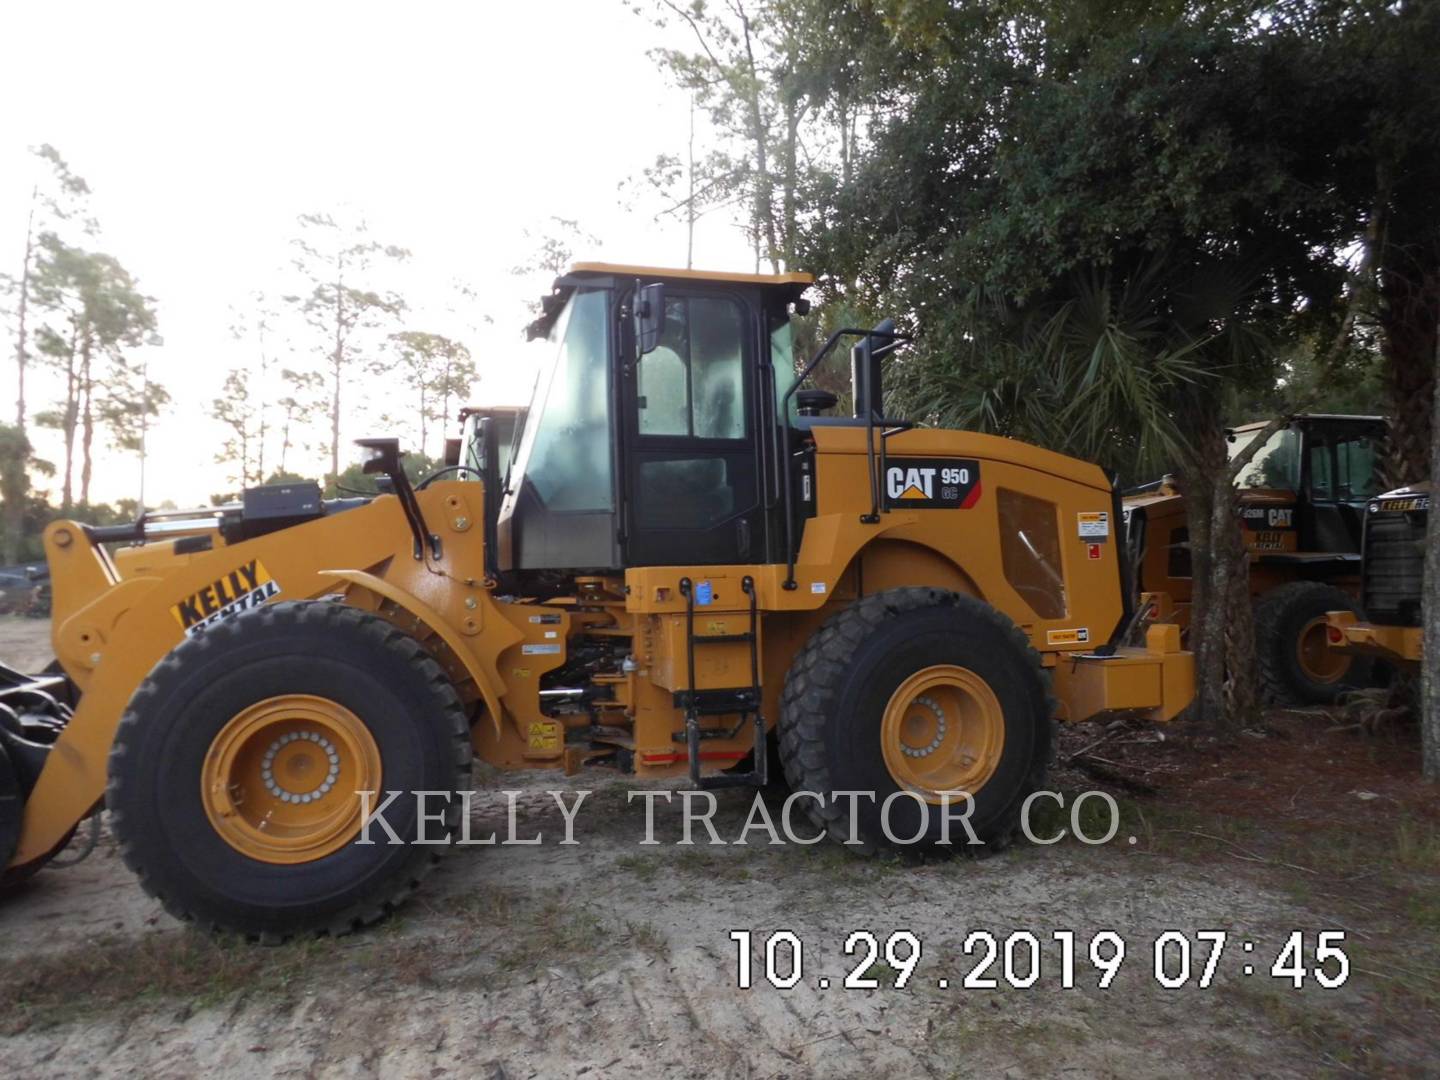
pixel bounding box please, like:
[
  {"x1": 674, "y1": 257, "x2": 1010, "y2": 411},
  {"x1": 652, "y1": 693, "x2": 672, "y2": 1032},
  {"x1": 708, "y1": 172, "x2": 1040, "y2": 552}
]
[{"x1": 107, "y1": 600, "x2": 471, "y2": 943}]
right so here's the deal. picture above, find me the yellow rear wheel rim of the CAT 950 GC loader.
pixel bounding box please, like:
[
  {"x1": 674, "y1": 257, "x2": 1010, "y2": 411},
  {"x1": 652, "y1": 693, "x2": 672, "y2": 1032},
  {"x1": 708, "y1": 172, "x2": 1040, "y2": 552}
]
[{"x1": 880, "y1": 664, "x2": 1005, "y2": 804}]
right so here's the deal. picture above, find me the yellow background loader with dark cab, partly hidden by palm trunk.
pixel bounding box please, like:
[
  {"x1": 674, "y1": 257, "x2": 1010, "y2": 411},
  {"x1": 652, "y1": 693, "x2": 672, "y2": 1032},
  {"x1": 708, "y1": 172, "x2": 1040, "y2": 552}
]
[{"x1": 1125, "y1": 413, "x2": 1385, "y2": 704}]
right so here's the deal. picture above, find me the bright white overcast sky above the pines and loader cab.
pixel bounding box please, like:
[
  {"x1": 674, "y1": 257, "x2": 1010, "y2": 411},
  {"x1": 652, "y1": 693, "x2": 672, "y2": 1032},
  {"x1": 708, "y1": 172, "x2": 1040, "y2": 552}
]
[{"x1": 0, "y1": 0, "x2": 750, "y2": 504}]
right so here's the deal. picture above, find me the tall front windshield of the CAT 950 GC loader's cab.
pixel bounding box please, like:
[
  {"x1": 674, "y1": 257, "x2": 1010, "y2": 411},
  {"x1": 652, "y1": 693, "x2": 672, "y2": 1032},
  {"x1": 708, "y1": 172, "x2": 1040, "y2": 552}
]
[{"x1": 511, "y1": 289, "x2": 615, "y2": 511}]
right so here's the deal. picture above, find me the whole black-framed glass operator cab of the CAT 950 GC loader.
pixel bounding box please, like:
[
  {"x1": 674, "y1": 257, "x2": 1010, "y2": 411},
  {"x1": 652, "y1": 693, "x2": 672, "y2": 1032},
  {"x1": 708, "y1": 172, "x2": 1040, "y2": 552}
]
[{"x1": 495, "y1": 264, "x2": 817, "y2": 576}]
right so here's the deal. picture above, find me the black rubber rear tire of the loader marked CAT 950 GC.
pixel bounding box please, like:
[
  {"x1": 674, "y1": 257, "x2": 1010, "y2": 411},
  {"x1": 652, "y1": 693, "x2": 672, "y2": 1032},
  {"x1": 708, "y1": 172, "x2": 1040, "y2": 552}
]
[{"x1": 779, "y1": 588, "x2": 1054, "y2": 854}]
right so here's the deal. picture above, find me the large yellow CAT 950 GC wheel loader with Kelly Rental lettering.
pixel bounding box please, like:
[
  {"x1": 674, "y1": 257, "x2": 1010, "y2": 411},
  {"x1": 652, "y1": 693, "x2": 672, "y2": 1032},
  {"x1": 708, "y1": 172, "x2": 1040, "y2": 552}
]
[{"x1": 0, "y1": 264, "x2": 1192, "y2": 939}]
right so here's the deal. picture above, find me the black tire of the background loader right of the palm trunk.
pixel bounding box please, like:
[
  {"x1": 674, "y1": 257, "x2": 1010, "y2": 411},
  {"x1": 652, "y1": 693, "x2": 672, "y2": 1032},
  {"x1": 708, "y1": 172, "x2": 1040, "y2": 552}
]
[{"x1": 1256, "y1": 582, "x2": 1375, "y2": 706}]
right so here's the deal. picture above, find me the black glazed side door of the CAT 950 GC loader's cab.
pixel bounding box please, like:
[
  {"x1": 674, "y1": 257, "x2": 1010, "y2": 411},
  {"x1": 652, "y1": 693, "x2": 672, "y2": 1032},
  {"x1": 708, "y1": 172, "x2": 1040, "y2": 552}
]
[{"x1": 622, "y1": 285, "x2": 765, "y2": 576}]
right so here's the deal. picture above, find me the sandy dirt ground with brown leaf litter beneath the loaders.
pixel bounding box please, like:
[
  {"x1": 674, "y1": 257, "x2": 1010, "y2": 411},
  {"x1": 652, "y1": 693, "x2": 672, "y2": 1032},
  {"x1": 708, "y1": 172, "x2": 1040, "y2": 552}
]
[{"x1": 0, "y1": 621, "x2": 1440, "y2": 1077}]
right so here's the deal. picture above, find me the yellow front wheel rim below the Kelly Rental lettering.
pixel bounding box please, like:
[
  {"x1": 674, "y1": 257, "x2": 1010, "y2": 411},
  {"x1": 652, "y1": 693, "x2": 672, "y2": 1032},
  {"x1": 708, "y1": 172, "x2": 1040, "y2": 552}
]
[{"x1": 200, "y1": 694, "x2": 380, "y2": 865}]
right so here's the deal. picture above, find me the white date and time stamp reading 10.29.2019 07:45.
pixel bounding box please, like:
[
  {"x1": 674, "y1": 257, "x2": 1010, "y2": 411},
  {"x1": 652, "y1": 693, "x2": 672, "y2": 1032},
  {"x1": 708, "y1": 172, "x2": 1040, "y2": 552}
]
[{"x1": 730, "y1": 930, "x2": 1349, "y2": 989}]
